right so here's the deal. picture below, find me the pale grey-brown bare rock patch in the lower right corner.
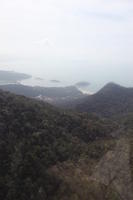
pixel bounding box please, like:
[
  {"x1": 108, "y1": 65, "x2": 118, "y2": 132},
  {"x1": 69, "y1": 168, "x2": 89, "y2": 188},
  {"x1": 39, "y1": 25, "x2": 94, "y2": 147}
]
[{"x1": 90, "y1": 138, "x2": 133, "y2": 200}]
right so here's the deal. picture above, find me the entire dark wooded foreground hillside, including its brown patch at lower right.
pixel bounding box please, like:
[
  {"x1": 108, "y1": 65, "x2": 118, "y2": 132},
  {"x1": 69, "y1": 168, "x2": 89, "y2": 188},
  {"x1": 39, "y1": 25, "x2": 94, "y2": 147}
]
[{"x1": 0, "y1": 82, "x2": 133, "y2": 200}]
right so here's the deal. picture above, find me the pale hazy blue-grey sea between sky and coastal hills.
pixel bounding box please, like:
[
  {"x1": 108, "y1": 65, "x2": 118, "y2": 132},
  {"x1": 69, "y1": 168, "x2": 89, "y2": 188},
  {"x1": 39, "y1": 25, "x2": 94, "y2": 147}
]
[{"x1": 0, "y1": 61, "x2": 133, "y2": 92}]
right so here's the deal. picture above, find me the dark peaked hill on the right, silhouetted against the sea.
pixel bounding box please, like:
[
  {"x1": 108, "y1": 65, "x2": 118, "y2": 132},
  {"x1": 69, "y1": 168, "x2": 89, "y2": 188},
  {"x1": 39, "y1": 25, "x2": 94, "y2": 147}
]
[{"x1": 76, "y1": 83, "x2": 133, "y2": 117}]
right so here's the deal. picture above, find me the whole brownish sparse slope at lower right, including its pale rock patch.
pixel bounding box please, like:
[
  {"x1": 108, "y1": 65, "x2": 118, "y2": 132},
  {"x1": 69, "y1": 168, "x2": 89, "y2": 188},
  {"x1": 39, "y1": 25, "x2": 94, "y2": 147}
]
[{"x1": 51, "y1": 136, "x2": 133, "y2": 200}]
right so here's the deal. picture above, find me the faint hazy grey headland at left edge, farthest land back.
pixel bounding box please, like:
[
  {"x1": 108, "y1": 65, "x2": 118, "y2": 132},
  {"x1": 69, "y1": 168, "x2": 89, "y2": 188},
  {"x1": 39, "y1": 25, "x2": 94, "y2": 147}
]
[{"x1": 0, "y1": 70, "x2": 31, "y2": 84}]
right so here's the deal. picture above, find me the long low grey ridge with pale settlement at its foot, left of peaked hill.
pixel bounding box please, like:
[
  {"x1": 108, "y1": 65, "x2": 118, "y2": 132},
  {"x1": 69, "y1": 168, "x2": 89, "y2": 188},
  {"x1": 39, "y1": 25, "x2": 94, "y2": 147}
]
[{"x1": 0, "y1": 84, "x2": 86, "y2": 107}]
